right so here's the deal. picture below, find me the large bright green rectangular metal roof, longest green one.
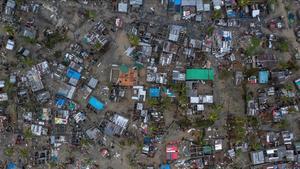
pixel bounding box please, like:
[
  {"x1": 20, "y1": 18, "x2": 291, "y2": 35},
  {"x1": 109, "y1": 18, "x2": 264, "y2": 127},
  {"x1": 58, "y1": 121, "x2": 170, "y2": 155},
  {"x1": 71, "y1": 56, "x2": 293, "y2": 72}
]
[{"x1": 185, "y1": 69, "x2": 215, "y2": 80}]
